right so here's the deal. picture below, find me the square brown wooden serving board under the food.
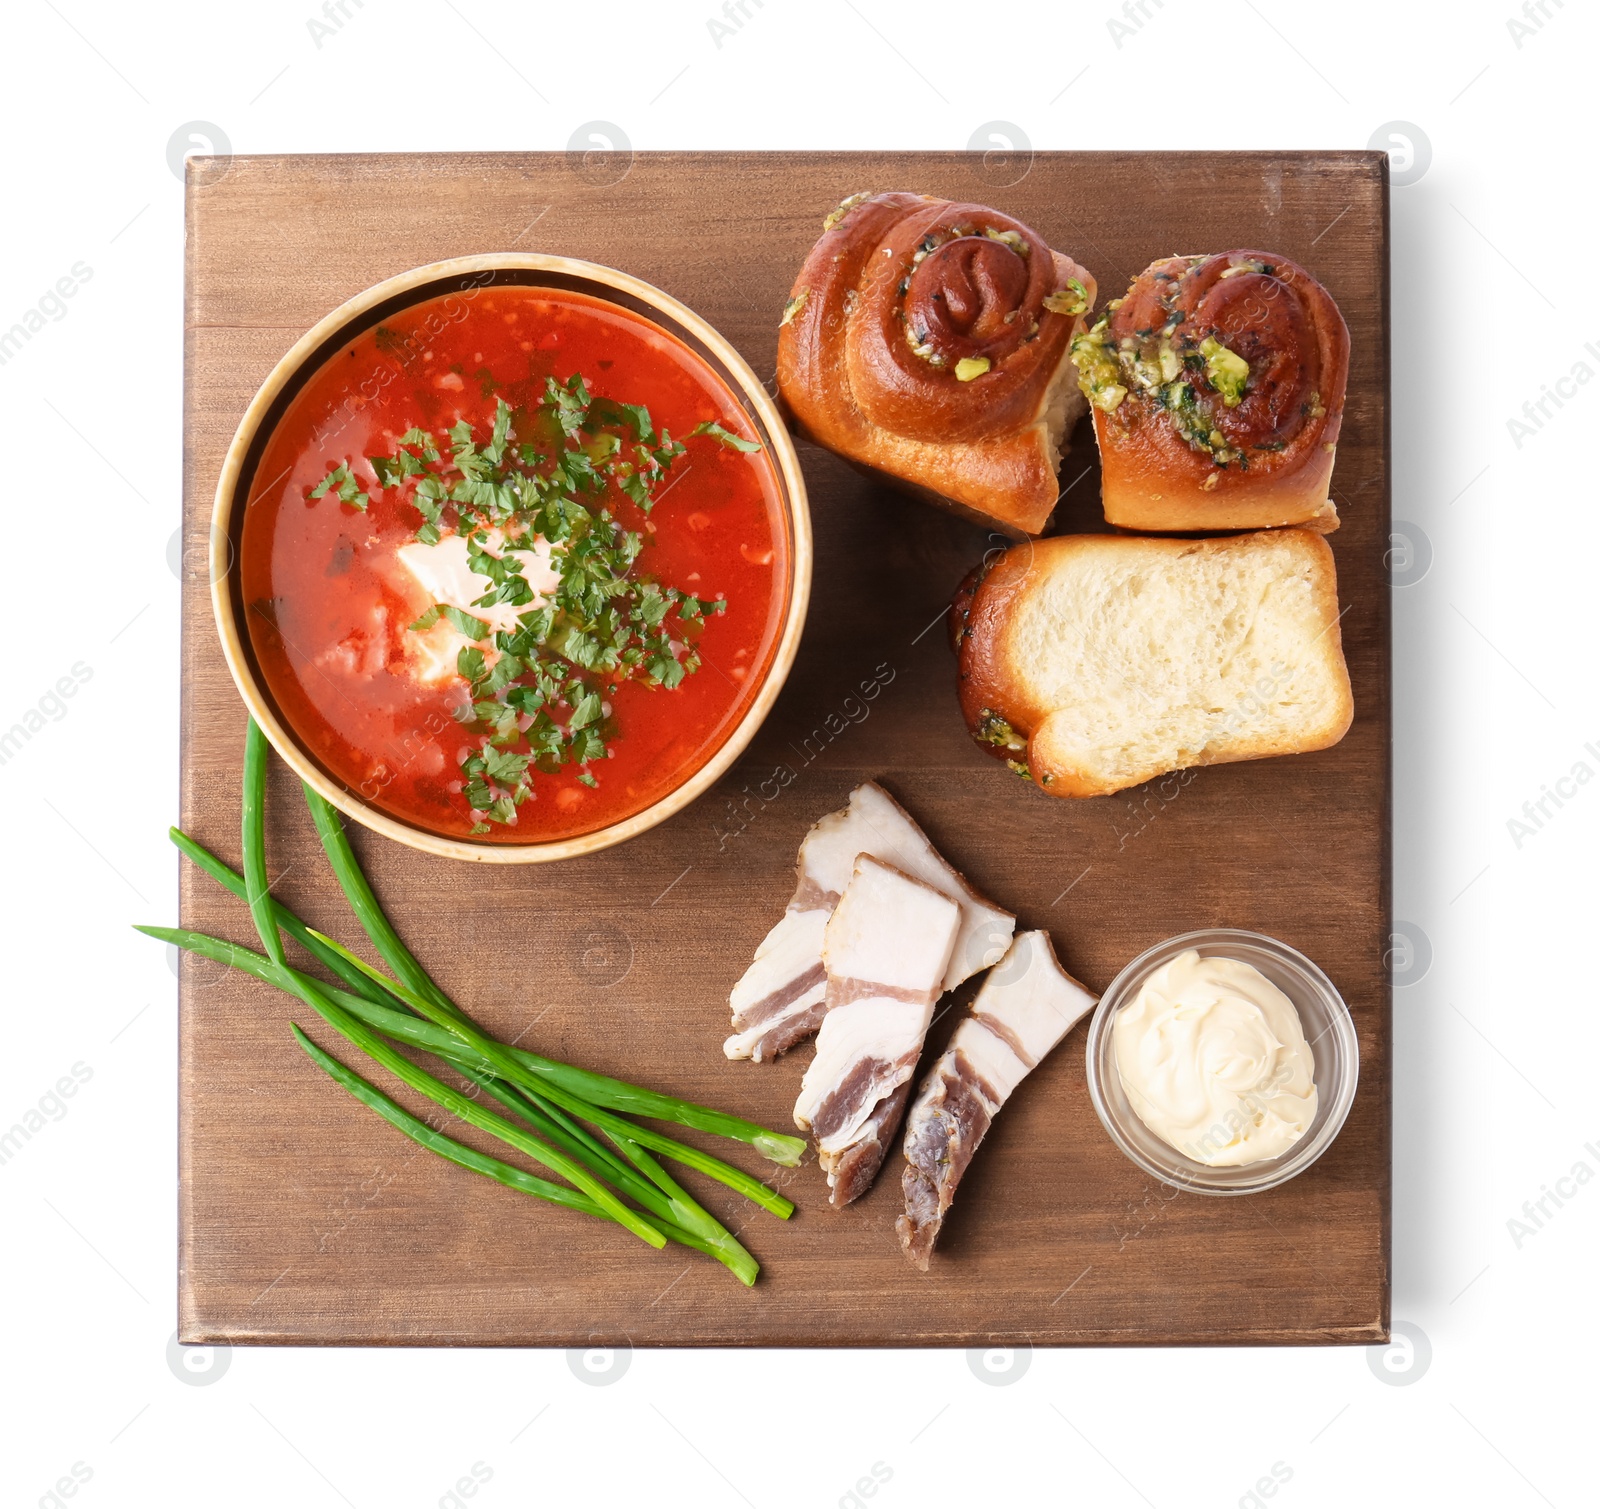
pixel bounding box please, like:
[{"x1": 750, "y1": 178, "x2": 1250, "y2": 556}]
[{"x1": 179, "y1": 152, "x2": 1390, "y2": 1346}]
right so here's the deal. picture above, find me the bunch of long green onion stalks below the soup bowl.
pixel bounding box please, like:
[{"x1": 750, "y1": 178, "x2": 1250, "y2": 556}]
[{"x1": 139, "y1": 720, "x2": 805, "y2": 1285}]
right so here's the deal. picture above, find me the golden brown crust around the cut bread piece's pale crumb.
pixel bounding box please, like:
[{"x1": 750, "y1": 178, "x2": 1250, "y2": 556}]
[{"x1": 952, "y1": 530, "x2": 1355, "y2": 797}]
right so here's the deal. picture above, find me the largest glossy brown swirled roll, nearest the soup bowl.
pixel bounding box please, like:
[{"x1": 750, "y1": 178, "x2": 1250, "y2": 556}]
[{"x1": 778, "y1": 194, "x2": 1096, "y2": 538}]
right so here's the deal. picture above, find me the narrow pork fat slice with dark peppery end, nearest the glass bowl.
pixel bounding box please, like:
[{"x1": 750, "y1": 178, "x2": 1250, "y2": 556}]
[{"x1": 894, "y1": 933, "x2": 1094, "y2": 1272}]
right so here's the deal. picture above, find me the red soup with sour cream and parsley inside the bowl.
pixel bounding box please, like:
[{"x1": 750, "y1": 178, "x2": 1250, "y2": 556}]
[{"x1": 240, "y1": 286, "x2": 789, "y2": 843}]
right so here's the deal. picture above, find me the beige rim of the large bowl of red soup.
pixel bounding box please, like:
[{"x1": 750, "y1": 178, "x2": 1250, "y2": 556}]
[{"x1": 210, "y1": 251, "x2": 813, "y2": 864}]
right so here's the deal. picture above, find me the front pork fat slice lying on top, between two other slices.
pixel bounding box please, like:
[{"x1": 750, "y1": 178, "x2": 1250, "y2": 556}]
[{"x1": 795, "y1": 855, "x2": 962, "y2": 1205}]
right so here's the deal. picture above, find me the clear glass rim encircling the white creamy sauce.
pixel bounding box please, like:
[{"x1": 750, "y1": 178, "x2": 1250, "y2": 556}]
[{"x1": 1083, "y1": 927, "x2": 1362, "y2": 1197}]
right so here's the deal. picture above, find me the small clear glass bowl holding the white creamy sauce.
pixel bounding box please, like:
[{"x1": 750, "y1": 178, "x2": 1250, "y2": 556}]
[{"x1": 1086, "y1": 928, "x2": 1360, "y2": 1195}]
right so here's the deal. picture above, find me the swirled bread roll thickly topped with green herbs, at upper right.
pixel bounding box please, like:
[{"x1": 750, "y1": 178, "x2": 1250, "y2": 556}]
[{"x1": 1072, "y1": 251, "x2": 1350, "y2": 534}]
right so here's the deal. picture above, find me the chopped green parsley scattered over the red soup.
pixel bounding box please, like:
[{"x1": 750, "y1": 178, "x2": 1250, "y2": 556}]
[{"x1": 310, "y1": 373, "x2": 760, "y2": 834}]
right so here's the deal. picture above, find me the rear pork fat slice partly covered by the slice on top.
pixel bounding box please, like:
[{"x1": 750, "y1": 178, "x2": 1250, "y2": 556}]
[{"x1": 723, "y1": 781, "x2": 1016, "y2": 1063}]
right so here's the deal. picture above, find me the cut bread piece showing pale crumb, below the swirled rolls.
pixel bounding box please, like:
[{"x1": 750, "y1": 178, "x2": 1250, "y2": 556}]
[{"x1": 954, "y1": 530, "x2": 1354, "y2": 797}]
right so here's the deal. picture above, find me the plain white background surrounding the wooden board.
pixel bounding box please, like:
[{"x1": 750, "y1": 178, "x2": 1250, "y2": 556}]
[{"x1": 0, "y1": 0, "x2": 1600, "y2": 1509}]
